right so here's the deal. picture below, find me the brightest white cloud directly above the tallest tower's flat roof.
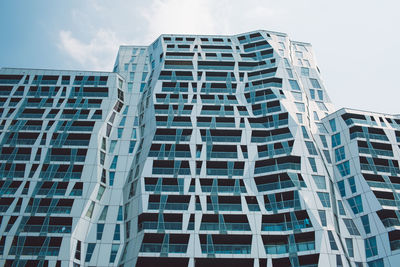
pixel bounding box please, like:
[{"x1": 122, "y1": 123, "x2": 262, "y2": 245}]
[{"x1": 138, "y1": 0, "x2": 285, "y2": 43}]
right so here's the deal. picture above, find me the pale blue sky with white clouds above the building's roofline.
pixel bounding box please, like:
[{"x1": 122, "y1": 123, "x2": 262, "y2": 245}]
[{"x1": 0, "y1": 0, "x2": 400, "y2": 114}]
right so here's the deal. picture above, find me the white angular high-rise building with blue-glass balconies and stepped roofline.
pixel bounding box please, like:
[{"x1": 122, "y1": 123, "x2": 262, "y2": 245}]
[{"x1": 0, "y1": 30, "x2": 400, "y2": 267}]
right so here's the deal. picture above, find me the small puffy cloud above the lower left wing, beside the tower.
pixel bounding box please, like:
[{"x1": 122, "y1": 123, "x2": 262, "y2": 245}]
[{"x1": 59, "y1": 29, "x2": 122, "y2": 70}]
